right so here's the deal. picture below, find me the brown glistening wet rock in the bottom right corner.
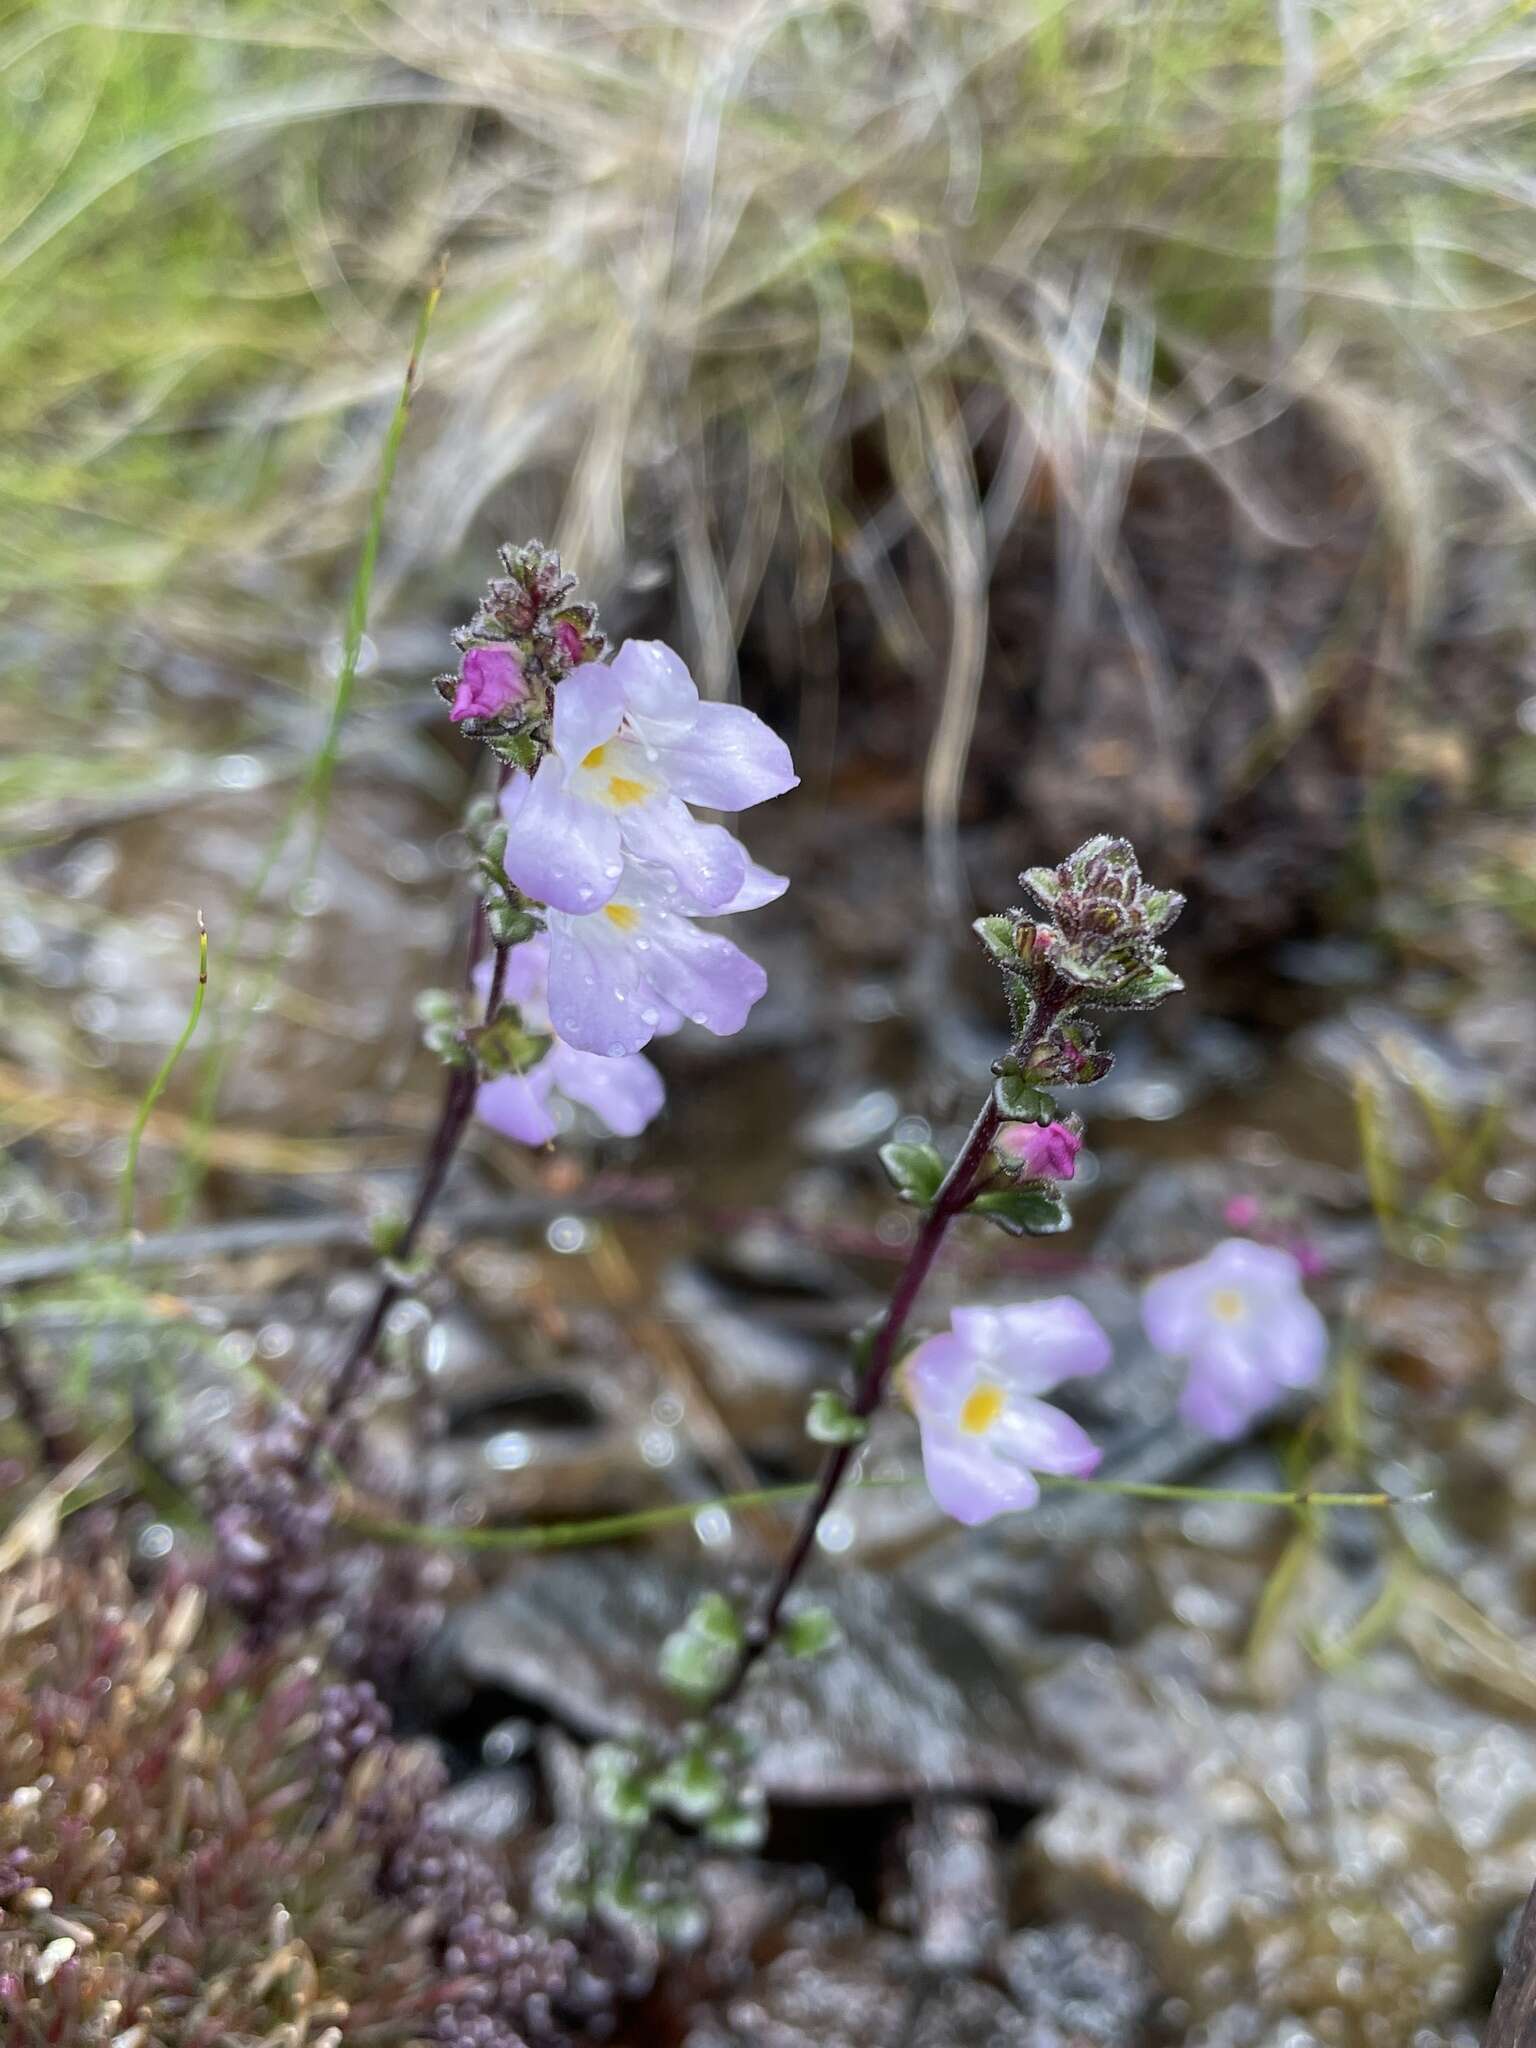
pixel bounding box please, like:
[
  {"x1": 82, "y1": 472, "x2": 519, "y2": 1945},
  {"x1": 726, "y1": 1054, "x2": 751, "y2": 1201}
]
[{"x1": 1030, "y1": 1630, "x2": 1536, "y2": 2048}]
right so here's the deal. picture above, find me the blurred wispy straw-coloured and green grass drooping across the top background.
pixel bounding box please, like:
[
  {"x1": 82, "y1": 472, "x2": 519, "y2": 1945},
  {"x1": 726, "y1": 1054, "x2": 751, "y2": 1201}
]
[{"x1": 0, "y1": 0, "x2": 1536, "y2": 893}]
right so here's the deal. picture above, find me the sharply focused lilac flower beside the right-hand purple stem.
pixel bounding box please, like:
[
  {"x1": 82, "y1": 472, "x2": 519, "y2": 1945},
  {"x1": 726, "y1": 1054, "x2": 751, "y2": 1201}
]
[{"x1": 901, "y1": 1294, "x2": 1110, "y2": 1526}]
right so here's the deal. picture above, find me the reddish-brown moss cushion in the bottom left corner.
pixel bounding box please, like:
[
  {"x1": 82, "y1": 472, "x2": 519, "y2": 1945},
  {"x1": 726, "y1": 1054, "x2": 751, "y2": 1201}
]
[{"x1": 0, "y1": 1559, "x2": 602, "y2": 2048}]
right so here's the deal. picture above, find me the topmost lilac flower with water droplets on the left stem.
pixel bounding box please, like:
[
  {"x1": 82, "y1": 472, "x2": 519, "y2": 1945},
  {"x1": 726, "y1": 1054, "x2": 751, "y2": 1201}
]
[{"x1": 502, "y1": 641, "x2": 799, "y2": 913}]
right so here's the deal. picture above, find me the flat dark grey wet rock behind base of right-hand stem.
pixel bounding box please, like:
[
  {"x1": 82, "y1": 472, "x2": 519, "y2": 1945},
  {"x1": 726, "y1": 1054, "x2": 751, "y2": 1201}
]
[{"x1": 434, "y1": 1550, "x2": 1044, "y2": 1804}]
